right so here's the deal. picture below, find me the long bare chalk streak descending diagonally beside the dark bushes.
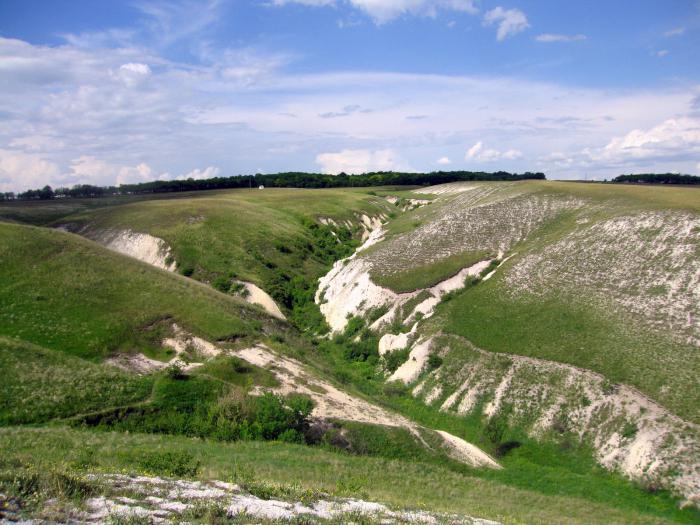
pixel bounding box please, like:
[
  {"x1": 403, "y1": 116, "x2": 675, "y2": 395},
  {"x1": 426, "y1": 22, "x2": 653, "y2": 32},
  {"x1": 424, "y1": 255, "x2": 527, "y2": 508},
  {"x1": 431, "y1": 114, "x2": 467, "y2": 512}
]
[{"x1": 233, "y1": 342, "x2": 498, "y2": 467}]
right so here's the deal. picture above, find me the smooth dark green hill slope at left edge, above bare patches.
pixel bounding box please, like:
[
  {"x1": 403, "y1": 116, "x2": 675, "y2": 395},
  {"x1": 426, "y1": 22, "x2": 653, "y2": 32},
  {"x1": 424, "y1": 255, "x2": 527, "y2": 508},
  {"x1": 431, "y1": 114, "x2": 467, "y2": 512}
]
[{"x1": 0, "y1": 223, "x2": 284, "y2": 360}]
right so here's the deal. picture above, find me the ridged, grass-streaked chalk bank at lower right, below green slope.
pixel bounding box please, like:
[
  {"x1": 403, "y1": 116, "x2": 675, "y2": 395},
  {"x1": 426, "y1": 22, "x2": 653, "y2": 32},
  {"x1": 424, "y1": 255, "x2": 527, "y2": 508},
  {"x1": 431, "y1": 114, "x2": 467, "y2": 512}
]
[{"x1": 414, "y1": 336, "x2": 700, "y2": 504}]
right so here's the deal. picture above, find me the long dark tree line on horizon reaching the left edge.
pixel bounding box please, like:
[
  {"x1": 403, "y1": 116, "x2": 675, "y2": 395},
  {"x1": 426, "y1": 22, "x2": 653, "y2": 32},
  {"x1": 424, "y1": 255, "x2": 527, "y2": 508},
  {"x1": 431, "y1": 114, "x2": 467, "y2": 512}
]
[{"x1": 0, "y1": 171, "x2": 545, "y2": 200}]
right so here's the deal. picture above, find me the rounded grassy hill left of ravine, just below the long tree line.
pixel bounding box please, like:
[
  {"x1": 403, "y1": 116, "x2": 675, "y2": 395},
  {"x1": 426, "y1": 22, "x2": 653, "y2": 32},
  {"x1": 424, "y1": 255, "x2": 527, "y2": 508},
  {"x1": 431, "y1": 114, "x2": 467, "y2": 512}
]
[{"x1": 55, "y1": 188, "x2": 390, "y2": 288}]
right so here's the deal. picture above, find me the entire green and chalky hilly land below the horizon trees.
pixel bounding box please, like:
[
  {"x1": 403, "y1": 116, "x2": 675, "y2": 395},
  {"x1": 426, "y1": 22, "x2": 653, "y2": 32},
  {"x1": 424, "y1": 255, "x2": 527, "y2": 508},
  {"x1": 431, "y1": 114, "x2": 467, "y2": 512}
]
[{"x1": 0, "y1": 181, "x2": 700, "y2": 523}]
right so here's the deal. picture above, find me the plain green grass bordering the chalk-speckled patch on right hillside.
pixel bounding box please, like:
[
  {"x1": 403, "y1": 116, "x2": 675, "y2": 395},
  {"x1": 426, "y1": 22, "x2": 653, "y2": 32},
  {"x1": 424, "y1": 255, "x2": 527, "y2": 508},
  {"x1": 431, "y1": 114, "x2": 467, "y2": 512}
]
[{"x1": 432, "y1": 182, "x2": 700, "y2": 422}]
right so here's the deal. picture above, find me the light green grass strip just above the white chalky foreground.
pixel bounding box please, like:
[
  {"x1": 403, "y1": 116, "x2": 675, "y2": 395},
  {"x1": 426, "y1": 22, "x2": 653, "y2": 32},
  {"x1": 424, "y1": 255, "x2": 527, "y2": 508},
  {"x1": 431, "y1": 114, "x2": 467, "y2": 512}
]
[{"x1": 0, "y1": 428, "x2": 697, "y2": 524}]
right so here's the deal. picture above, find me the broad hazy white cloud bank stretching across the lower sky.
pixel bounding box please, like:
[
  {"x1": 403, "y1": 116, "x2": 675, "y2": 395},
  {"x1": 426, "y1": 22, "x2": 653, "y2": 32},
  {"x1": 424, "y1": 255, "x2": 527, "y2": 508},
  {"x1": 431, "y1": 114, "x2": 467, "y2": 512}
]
[{"x1": 0, "y1": 32, "x2": 700, "y2": 186}]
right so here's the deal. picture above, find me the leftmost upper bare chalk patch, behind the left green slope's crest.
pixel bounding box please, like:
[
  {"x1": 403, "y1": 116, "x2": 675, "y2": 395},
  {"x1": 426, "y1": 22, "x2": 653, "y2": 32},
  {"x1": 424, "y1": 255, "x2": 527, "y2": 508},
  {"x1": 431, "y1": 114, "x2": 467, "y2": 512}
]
[{"x1": 94, "y1": 230, "x2": 177, "y2": 272}]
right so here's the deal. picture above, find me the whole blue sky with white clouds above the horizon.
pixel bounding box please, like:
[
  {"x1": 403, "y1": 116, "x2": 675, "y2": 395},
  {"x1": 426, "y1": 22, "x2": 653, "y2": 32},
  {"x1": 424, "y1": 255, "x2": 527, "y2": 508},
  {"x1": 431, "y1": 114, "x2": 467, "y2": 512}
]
[{"x1": 0, "y1": 0, "x2": 700, "y2": 191}]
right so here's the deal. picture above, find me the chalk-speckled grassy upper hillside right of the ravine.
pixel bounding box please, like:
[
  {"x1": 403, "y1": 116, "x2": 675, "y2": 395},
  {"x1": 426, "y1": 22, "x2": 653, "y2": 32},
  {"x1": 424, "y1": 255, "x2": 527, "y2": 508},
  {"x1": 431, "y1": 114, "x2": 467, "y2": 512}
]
[{"x1": 356, "y1": 181, "x2": 700, "y2": 422}]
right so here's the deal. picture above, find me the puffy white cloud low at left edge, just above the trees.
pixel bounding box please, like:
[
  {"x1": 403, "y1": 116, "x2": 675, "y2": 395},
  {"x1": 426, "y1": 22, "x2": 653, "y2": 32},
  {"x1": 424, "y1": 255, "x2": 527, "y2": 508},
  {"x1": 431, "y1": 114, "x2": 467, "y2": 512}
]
[{"x1": 0, "y1": 149, "x2": 60, "y2": 191}]
